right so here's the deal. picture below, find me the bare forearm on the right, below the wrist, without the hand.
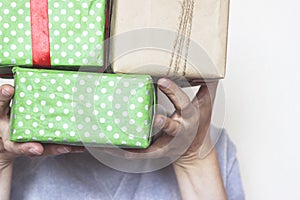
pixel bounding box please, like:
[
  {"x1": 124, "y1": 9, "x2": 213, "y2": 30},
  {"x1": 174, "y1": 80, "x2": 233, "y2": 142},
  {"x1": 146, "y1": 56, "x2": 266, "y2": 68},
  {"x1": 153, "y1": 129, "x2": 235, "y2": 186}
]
[{"x1": 174, "y1": 150, "x2": 227, "y2": 200}]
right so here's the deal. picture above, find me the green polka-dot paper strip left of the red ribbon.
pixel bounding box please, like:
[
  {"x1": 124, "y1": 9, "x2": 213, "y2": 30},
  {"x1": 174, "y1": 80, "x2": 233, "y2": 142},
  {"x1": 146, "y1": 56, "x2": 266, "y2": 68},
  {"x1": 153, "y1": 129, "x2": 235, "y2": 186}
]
[{"x1": 0, "y1": 1, "x2": 32, "y2": 65}]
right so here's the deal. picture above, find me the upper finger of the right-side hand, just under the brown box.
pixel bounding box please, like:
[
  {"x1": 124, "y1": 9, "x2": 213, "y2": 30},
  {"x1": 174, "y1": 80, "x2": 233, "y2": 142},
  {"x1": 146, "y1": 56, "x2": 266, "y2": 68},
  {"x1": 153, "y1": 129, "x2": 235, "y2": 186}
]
[{"x1": 157, "y1": 78, "x2": 191, "y2": 111}]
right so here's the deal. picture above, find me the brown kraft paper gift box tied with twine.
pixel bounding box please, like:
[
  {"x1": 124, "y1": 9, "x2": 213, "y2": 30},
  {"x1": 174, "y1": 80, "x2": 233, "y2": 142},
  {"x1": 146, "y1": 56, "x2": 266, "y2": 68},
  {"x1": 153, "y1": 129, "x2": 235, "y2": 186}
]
[{"x1": 110, "y1": 0, "x2": 229, "y2": 81}]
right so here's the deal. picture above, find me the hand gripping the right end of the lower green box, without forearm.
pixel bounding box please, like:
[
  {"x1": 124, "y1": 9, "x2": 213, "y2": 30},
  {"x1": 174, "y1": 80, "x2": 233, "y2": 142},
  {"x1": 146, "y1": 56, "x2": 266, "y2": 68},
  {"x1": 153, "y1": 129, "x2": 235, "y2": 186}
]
[{"x1": 102, "y1": 78, "x2": 217, "y2": 164}]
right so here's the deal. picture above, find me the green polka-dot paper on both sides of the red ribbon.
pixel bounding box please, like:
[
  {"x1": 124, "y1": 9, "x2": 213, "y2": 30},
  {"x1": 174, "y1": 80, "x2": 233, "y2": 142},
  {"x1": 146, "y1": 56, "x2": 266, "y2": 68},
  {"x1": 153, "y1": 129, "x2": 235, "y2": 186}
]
[{"x1": 0, "y1": 0, "x2": 106, "y2": 68}]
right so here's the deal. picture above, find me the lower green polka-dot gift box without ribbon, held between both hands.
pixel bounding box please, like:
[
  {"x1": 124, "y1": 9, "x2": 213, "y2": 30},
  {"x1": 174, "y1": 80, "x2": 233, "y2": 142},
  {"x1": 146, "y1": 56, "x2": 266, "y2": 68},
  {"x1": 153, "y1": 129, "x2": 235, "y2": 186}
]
[{"x1": 10, "y1": 67, "x2": 156, "y2": 148}]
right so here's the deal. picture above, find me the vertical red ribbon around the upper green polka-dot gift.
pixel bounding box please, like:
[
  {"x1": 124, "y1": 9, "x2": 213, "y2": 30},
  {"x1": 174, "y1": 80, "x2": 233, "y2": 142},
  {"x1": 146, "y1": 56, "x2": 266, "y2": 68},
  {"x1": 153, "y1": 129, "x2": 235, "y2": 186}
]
[{"x1": 30, "y1": 0, "x2": 51, "y2": 68}]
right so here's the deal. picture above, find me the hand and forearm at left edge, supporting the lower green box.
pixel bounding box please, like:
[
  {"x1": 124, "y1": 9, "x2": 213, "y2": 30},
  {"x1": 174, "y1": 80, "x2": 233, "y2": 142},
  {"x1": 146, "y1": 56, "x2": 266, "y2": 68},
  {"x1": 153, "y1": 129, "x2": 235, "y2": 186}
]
[{"x1": 0, "y1": 85, "x2": 84, "y2": 200}]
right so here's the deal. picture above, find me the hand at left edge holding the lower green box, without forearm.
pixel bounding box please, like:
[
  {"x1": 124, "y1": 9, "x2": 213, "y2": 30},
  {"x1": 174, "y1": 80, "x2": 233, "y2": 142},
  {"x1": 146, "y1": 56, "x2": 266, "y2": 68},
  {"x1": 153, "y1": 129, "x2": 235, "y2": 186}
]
[{"x1": 0, "y1": 85, "x2": 84, "y2": 167}]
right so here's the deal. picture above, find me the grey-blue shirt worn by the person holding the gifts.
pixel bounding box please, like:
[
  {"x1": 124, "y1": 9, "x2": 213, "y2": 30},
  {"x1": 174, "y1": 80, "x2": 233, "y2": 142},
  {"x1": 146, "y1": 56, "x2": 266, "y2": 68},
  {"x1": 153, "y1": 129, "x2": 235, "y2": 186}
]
[{"x1": 11, "y1": 128, "x2": 244, "y2": 200}]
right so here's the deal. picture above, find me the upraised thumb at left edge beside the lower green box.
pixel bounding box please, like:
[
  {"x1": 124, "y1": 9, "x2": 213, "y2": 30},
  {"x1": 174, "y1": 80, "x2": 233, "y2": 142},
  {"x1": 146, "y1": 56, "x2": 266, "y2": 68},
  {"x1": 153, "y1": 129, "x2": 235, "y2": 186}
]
[{"x1": 0, "y1": 85, "x2": 14, "y2": 117}]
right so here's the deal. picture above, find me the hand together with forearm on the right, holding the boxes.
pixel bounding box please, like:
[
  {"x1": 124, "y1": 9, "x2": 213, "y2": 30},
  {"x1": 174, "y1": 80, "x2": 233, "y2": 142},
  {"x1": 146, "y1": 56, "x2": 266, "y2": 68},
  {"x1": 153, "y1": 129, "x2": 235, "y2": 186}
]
[{"x1": 112, "y1": 79, "x2": 226, "y2": 200}]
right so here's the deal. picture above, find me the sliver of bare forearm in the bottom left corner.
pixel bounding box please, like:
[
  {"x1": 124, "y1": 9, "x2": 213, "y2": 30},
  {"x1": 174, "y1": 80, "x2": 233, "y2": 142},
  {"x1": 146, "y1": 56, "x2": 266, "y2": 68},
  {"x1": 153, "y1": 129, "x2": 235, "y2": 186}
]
[{"x1": 0, "y1": 162, "x2": 13, "y2": 200}]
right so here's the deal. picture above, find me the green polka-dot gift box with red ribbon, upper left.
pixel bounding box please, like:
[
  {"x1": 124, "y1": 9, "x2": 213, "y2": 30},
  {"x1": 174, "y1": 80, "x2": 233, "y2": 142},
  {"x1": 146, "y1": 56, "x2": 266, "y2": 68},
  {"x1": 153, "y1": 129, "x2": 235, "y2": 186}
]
[{"x1": 0, "y1": 0, "x2": 106, "y2": 74}]
